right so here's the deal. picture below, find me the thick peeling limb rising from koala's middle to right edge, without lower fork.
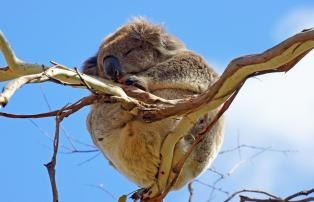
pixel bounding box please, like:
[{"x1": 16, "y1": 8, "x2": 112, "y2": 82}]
[{"x1": 136, "y1": 29, "x2": 314, "y2": 120}]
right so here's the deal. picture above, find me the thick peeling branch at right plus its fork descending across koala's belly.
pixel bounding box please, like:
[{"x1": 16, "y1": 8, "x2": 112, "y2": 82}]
[{"x1": 141, "y1": 29, "x2": 314, "y2": 198}]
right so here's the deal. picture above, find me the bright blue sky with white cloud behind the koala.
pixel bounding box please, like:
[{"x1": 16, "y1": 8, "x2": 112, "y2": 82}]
[{"x1": 0, "y1": 0, "x2": 314, "y2": 202}]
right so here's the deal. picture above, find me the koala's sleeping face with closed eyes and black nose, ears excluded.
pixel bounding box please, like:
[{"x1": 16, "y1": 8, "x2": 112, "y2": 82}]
[{"x1": 98, "y1": 32, "x2": 160, "y2": 81}]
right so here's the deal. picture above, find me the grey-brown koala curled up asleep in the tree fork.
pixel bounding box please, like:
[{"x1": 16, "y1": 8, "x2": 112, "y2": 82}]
[{"x1": 83, "y1": 18, "x2": 224, "y2": 193}]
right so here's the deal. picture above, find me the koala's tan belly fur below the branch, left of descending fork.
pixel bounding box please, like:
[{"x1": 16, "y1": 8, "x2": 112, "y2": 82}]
[{"x1": 87, "y1": 103, "x2": 178, "y2": 187}]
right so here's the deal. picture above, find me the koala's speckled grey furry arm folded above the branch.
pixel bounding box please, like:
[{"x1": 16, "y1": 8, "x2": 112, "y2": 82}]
[{"x1": 135, "y1": 51, "x2": 219, "y2": 93}]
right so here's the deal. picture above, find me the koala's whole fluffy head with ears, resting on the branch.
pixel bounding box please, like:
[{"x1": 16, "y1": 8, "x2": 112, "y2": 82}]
[{"x1": 83, "y1": 17, "x2": 185, "y2": 81}]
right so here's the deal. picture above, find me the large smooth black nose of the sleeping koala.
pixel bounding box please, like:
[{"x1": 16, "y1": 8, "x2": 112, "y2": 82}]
[{"x1": 104, "y1": 55, "x2": 122, "y2": 81}]
